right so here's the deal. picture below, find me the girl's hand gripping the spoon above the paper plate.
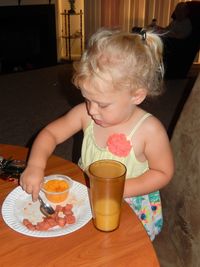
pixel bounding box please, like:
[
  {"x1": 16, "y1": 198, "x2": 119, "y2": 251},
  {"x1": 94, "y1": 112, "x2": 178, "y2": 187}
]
[{"x1": 20, "y1": 166, "x2": 44, "y2": 201}]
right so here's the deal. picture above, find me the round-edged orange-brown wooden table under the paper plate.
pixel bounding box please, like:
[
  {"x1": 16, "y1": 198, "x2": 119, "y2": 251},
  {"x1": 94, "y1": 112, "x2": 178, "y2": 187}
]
[{"x1": 0, "y1": 145, "x2": 159, "y2": 267}]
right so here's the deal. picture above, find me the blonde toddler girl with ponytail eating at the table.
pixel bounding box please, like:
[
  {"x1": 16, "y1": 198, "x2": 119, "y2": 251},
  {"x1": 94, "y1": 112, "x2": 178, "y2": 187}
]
[{"x1": 20, "y1": 29, "x2": 174, "y2": 240}]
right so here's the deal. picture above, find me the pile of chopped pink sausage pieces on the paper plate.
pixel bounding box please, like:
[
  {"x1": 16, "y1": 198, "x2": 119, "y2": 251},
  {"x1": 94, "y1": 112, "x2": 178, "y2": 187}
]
[{"x1": 22, "y1": 204, "x2": 76, "y2": 231}]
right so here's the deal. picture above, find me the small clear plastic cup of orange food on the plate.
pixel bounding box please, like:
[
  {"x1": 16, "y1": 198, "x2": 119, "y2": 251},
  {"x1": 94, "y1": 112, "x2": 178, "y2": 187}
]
[{"x1": 42, "y1": 175, "x2": 72, "y2": 203}]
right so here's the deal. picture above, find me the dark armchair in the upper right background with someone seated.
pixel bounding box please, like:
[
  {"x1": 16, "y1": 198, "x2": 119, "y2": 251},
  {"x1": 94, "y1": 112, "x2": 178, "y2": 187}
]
[{"x1": 162, "y1": 1, "x2": 200, "y2": 79}]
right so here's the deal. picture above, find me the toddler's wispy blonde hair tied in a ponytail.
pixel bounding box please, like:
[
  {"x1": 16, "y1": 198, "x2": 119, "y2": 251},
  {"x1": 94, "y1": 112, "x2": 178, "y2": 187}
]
[{"x1": 73, "y1": 29, "x2": 164, "y2": 96}]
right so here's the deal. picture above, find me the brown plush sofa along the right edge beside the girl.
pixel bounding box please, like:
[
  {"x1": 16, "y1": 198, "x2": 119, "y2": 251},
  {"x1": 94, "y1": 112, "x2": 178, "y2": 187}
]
[{"x1": 153, "y1": 71, "x2": 200, "y2": 267}]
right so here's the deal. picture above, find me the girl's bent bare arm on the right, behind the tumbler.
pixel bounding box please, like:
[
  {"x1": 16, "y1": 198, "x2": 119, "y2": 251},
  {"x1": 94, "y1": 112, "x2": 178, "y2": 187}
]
[{"x1": 124, "y1": 118, "x2": 174, "y2": 197}]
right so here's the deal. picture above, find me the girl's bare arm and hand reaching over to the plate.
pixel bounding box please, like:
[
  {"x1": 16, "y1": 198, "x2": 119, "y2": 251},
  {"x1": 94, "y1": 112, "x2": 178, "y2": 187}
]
[{"x1": 20, "y1": 104, "x2": 87, "y2": 201}]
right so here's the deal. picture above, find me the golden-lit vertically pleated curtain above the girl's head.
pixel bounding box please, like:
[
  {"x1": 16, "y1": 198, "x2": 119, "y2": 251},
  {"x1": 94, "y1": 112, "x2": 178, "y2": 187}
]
[{"x1": 84, "y1": 0, "x2": 191, "y2": 36}]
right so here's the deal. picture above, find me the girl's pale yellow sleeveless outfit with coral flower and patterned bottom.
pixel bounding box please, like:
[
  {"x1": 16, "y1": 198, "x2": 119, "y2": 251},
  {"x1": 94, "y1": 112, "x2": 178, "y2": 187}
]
[{"x1": 79, "y1": 113, "x2": 163, "y2": 240}]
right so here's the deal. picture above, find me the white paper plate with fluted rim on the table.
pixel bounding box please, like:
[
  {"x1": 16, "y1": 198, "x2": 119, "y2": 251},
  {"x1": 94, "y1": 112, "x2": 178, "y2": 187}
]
[{"x1": 2, "y1": 181, "x2": 92, "y2": 237}]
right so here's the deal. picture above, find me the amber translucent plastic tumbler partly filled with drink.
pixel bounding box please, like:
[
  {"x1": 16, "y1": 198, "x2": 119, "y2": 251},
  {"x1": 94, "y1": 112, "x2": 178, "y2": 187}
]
[{"x1": 87, "y1": 160, "x2": 126, "y2": 232}]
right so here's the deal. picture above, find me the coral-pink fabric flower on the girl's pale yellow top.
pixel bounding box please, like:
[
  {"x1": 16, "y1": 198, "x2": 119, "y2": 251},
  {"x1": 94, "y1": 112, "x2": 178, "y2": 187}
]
[{"x1": 107, "y1": 134, "x2": 132, "y2": 157}]
